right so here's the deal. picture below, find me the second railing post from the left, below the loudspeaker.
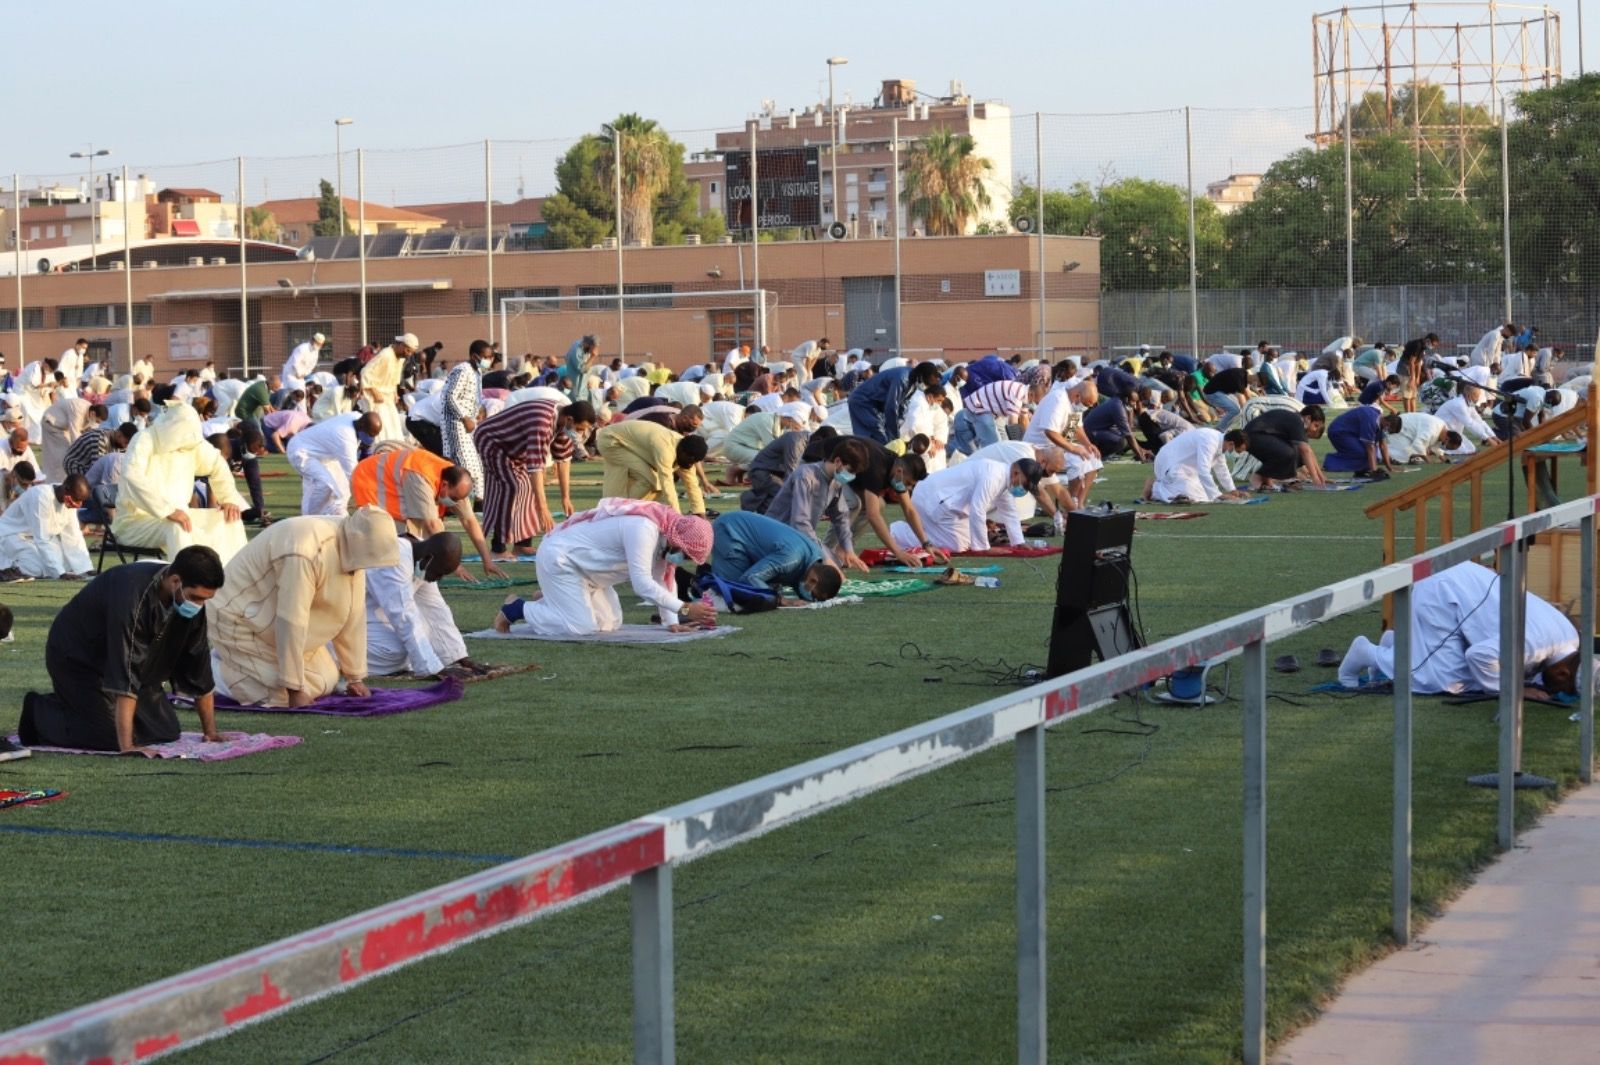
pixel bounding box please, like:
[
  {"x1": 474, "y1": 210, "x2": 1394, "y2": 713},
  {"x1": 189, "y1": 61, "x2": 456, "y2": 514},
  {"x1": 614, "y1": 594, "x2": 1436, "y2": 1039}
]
[{"x1": 1016, "y1": 724, "x2": 1050, "y2": 1065}]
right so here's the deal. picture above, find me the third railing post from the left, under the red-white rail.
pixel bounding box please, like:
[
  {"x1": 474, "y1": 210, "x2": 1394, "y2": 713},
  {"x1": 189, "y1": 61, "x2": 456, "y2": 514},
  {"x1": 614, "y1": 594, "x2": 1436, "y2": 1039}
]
[{"x1": 1243, "y1": 638, "x2": 1267, "y2": 1065}]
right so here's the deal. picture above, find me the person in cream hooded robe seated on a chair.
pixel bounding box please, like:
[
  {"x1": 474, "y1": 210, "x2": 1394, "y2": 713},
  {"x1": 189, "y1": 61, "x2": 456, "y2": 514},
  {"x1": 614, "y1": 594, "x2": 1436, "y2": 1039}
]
[{"x1": 110, "y1": 400, "x2": 245, "y2": 564}]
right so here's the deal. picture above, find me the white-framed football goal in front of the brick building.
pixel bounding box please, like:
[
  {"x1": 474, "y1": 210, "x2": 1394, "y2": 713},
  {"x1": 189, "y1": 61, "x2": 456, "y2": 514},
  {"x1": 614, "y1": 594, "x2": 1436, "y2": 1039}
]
[{"x1": 499, "y1": 285, "x2": 774, "y2": 369}]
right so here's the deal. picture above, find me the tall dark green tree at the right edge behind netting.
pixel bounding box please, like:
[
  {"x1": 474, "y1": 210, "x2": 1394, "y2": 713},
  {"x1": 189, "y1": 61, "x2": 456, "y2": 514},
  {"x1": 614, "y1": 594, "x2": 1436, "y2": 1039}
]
[{"x1": 1477, "y1": 74, "x2": 1600, "y2": 286}]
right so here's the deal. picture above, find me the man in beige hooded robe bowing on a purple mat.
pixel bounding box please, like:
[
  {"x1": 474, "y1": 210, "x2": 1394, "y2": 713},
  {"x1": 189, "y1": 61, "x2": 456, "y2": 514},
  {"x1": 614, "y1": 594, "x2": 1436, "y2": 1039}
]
[{"x1": 211, "y1": 507, "x2": 398, "y2": 707}]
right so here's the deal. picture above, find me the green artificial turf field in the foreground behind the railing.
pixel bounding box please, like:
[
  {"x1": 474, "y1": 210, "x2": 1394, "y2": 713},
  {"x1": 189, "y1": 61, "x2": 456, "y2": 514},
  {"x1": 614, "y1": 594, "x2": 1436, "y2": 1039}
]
[{"x1": 0, "y1": 447, "x2": 1578, "y2": 1065}]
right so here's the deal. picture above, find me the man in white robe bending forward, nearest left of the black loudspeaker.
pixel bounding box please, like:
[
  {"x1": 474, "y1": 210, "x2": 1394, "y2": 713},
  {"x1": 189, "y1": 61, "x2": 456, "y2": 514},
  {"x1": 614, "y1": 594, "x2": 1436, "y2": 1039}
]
[{"x1": 890, "y1": 459, "x2": 1045, "y2": 552}]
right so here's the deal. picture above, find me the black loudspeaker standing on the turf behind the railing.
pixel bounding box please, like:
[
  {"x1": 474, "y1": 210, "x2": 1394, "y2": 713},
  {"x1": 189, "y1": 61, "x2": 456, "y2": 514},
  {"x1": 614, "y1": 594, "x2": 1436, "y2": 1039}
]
[{"x1": 1046, "y1": 507, "x2": 1144, "y2": 676}]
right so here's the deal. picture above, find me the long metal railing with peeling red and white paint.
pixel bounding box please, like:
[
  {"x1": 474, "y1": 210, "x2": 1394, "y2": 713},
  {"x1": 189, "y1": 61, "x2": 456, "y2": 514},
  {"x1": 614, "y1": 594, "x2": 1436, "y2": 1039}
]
[{"x1": 0, "y1": 496, "x2": 1600, "y2": 1065}]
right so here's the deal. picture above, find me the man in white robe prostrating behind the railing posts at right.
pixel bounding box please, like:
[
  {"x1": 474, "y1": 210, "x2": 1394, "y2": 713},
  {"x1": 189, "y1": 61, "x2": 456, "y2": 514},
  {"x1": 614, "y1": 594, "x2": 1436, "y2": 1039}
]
[{"x1": 1339, "y1": 563, "x2": 1579, "y2": 696}]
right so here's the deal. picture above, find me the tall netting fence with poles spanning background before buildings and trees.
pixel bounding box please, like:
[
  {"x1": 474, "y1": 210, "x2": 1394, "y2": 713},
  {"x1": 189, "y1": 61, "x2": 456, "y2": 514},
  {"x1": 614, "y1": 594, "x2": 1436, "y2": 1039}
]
[{"x1": 0, "y1": 74, "x2": 1600, "y2": 382}]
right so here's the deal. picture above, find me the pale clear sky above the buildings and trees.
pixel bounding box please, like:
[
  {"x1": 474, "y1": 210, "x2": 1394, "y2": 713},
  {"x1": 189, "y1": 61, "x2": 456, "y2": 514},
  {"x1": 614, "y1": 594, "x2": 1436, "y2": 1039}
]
[{"x1": 15, "y1": 0, "x2": 1600, "y2": 201}]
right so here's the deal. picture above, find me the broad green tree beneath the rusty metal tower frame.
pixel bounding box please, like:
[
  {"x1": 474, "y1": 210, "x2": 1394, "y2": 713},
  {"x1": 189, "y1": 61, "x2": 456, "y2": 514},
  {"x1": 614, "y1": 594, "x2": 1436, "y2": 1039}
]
[{"x1": 1226, "y1": 136, "x2": 1499, "y2": 288}]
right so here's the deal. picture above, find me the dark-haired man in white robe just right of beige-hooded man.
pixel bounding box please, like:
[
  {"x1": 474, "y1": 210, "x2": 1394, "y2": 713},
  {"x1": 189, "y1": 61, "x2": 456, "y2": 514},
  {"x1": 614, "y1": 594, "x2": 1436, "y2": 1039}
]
[{"x1": 366, "y1": 533, "x2": 477, "y2": 676}]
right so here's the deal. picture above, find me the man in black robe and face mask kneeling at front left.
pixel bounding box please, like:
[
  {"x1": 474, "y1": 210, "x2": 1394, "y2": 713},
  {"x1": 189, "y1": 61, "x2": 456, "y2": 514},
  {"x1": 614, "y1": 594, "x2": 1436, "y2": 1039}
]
[{"x1": 18, "y1": 561, "x2": 214, "y2": 750}]
